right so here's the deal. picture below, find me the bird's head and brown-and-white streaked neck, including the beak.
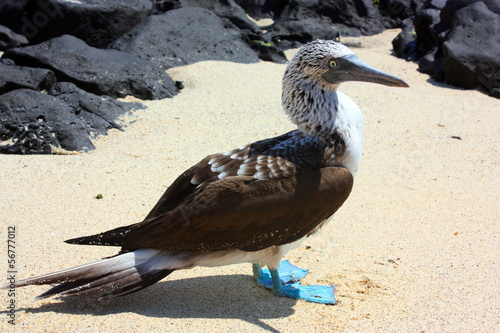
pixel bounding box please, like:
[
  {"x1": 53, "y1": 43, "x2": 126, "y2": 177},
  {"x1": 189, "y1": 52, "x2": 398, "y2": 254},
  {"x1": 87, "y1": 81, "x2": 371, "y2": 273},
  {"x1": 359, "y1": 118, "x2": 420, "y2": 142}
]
[{"x1": 282, "y1": 40, "x2": 408, "y2": 142}]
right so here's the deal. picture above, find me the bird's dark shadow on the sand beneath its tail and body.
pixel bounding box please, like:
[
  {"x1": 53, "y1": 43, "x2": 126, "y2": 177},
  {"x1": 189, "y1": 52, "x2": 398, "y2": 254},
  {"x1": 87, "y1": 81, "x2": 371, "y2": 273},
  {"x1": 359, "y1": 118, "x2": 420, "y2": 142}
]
[{"x1": 13, "y1": 275, "x2": 297, "y2": 332}]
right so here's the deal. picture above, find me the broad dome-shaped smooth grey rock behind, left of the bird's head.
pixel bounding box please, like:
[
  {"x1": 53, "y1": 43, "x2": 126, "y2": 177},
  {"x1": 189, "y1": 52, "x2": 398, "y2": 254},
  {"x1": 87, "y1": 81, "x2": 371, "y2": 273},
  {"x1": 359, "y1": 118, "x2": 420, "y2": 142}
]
[{"x1": 111, "y1": 7, "x2": 259, "y2": 68}]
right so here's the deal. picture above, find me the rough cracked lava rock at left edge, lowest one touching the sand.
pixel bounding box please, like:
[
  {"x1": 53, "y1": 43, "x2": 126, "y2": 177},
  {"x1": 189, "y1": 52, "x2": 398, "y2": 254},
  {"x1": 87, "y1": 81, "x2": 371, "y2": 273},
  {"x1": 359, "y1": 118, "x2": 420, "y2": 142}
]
[{"x1": 0, "y1": 82, "x2": 144, "y2": 154}]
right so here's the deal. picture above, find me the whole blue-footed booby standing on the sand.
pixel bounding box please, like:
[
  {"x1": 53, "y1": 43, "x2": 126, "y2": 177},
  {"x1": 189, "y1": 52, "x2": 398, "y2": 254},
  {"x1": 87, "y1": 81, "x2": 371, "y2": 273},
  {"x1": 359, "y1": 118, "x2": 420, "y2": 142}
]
[{"x1": 1, "y1": 40, "x2": 408, "y2": 304}]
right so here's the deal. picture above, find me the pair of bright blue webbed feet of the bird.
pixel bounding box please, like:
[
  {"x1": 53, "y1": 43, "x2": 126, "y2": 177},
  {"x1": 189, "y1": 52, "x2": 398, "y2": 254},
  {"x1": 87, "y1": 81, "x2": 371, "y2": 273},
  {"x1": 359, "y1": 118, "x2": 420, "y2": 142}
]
[{"x1": 253, "y1": 260, "x2": 337, "y2": 304}]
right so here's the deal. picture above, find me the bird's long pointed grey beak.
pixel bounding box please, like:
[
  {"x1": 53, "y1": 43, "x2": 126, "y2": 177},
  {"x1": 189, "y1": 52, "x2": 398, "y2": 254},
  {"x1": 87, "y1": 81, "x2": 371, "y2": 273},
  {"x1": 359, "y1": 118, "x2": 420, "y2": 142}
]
[{"x1": 323, "y1": 54, "x2": 409, "y2": 87}]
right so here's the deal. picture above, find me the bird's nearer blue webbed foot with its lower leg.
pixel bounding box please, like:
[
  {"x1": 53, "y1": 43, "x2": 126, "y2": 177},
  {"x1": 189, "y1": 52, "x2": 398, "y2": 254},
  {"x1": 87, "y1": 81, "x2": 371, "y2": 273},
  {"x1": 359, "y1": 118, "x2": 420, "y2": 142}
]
[{"x1": 271, "y1": 270, "x2": 337, "y2": 304}]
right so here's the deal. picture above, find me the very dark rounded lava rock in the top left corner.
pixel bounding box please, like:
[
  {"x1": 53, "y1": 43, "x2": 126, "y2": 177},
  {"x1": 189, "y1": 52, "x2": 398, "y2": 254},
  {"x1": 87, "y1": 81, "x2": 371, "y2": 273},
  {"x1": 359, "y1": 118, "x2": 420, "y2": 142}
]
[{"x1": 0, "y1": 0, "x2": 153, "y2": 48}]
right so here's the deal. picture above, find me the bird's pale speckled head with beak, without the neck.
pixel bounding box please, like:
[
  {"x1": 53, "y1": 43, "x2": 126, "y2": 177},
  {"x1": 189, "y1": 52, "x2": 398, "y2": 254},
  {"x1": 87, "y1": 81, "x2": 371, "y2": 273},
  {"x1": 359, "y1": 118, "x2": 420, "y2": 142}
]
[{"x1": 283, "y1": 40, "x2": 408, "y2": 91}]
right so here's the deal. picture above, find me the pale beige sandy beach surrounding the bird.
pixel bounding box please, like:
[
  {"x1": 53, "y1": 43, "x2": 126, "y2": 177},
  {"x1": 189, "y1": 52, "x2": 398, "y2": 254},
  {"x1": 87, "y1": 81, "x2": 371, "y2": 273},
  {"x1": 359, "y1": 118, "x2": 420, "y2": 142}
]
[{"x1": 0, "y1": 30, "x2": 500, "y2": 332}]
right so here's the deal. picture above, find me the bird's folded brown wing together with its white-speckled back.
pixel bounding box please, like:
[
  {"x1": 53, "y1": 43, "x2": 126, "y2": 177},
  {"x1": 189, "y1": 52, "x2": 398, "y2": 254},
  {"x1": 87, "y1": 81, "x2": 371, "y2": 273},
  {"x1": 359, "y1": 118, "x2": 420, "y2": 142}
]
[{"x1": 67, "y1": 131, "x2": 353, "y2": 252}]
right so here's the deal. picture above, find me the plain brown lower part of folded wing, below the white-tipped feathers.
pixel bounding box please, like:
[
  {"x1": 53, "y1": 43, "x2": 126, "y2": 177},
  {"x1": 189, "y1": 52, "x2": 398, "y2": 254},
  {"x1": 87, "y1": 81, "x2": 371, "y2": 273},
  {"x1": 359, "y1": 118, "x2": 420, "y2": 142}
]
[{"x1": 116, "y1": 167, "x2": 353, "y2": 251}]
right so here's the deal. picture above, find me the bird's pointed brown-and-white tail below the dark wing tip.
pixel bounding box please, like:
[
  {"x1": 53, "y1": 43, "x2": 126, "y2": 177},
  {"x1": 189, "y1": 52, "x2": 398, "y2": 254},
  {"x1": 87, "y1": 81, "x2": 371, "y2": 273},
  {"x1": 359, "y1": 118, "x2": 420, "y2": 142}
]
[{"x1": 0, "y1": 250, "x2": 175, "y2": 299}]
